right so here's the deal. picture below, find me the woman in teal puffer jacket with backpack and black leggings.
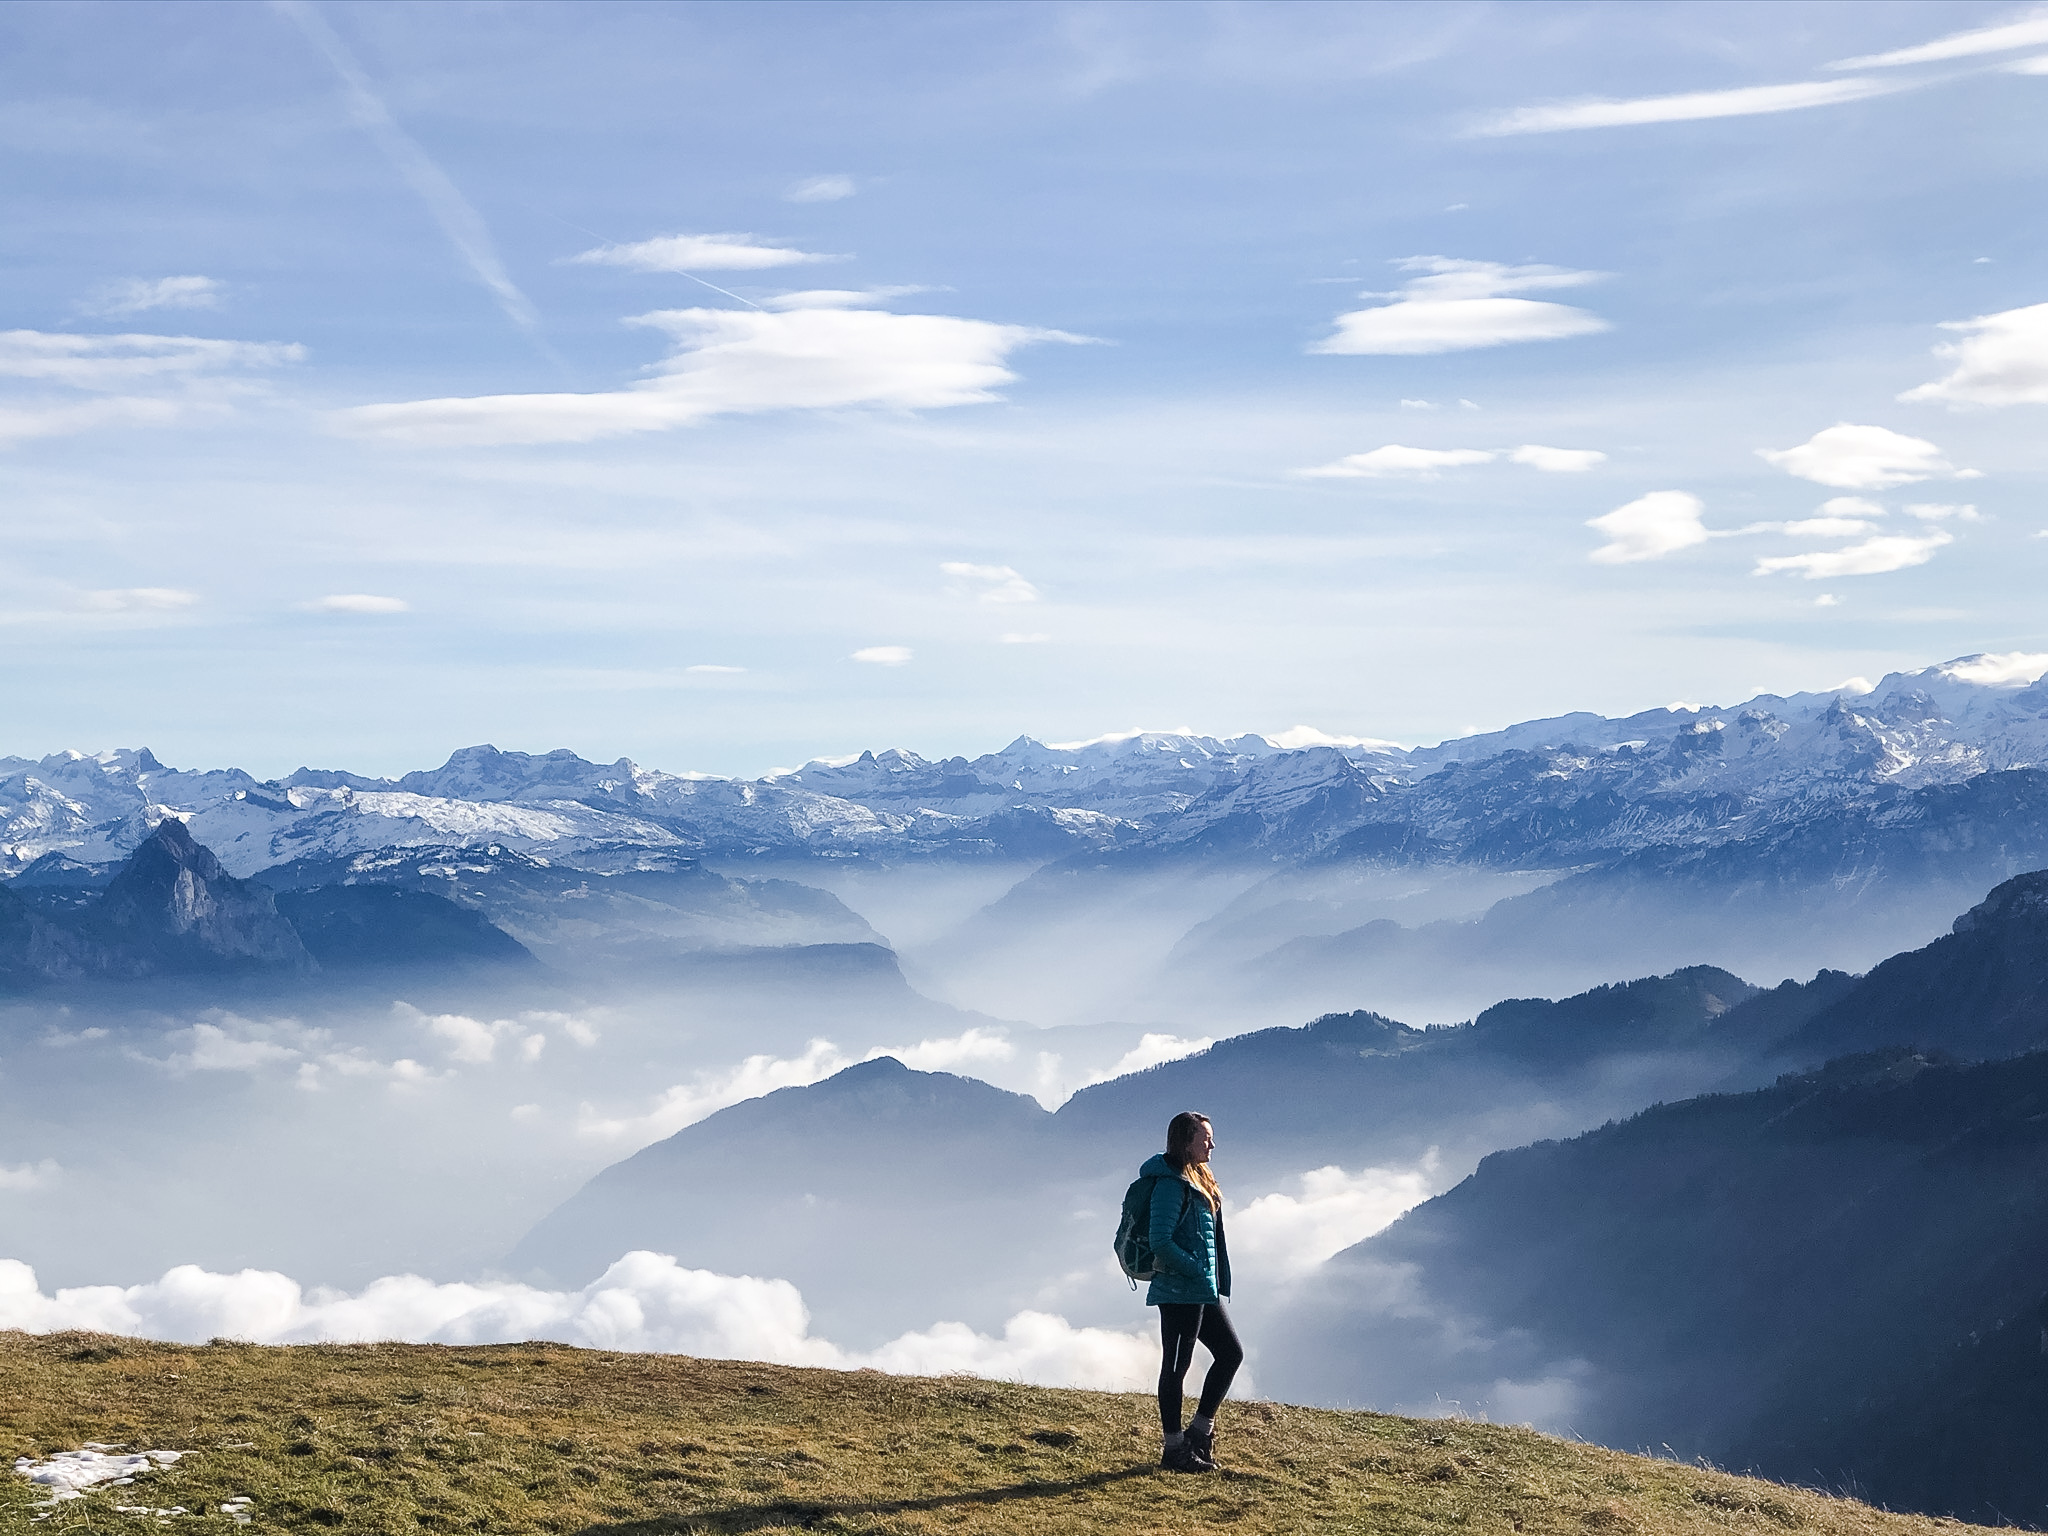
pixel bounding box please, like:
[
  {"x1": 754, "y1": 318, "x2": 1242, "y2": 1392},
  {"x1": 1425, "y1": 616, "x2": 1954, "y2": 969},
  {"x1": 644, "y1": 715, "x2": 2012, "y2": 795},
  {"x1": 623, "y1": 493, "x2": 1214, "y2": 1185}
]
[{"x1": 1139, "y1": 1110, "x2": 1245, "y2": 1473}]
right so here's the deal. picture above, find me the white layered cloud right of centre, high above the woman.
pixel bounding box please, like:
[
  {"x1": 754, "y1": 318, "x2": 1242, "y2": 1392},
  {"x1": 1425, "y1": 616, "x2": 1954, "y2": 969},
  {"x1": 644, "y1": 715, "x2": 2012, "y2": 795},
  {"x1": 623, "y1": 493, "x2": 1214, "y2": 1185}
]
[{"x1": 1309, "y1": 256, "x2": 1608, "y2": 356}]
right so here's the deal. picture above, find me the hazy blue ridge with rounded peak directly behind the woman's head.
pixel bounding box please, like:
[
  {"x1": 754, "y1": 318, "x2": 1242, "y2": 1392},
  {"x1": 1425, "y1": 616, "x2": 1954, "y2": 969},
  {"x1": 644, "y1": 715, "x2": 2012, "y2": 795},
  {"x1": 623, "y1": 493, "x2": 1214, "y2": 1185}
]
[{"x1": 508, "y1": 967, "x2": 1826, "y2": 1337}]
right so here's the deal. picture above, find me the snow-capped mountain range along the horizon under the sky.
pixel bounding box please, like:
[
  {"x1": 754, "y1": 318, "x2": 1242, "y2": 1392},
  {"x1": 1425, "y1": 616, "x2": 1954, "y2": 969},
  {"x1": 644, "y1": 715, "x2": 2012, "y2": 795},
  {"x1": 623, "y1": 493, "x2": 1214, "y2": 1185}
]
[{"x1": 0, "y1": 655, "x2": 2048, "y2": 879}]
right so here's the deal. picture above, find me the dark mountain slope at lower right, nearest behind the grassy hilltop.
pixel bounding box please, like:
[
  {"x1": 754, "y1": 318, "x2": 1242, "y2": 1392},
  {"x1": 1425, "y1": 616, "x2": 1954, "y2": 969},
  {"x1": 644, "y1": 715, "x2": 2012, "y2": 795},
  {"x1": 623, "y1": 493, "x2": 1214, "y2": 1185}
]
[{"x1": 1262, "y1": 1049, "x2": 2048, "y2": 1524}]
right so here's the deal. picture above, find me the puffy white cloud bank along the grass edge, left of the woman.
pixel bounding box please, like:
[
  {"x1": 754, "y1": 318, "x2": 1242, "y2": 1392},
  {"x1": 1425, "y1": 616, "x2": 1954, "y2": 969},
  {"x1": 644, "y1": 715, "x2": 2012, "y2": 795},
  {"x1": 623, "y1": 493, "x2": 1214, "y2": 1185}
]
[{"x1": 0, "y1": 1251, "x2": 1157, "y2": 1391}]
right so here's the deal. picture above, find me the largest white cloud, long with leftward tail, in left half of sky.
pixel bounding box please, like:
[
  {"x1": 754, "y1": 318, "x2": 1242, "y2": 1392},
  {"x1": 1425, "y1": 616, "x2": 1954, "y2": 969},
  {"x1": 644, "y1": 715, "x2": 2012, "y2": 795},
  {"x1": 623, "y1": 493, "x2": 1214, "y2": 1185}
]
[{"x1": 338, "y1": 309, "x2": 1083, "y2": 444}]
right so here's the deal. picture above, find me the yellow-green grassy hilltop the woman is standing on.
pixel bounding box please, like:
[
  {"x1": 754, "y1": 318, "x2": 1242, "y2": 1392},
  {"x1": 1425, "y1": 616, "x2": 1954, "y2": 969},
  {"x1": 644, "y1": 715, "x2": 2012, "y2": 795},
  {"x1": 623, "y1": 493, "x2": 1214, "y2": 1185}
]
[{"x1": 0, "y1": 1333, "x2": 1998, "y2": 1536}]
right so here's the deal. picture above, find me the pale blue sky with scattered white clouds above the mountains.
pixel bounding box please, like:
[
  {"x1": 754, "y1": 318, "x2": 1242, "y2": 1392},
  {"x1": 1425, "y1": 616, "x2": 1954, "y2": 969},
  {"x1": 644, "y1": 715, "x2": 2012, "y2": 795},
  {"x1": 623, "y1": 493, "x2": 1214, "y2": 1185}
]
[{"x1": 0, "y1": 2, "x2": 2048, "y2": 772}]
